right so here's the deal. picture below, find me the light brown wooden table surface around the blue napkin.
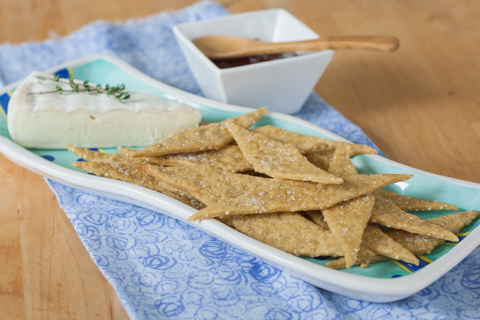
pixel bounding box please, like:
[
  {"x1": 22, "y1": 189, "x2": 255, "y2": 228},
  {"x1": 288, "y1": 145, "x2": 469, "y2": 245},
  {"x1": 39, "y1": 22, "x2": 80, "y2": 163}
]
[{"x1": 0, "y1": 0, "x2": 480, "y2": 319}]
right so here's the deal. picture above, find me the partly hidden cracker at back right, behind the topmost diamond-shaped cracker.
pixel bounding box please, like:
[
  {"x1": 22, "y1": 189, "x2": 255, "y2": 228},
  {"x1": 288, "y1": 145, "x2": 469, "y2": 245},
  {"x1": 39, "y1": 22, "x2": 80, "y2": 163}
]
[{"x1": 252, "y1": 125, "x2": 377, "y2": 156}]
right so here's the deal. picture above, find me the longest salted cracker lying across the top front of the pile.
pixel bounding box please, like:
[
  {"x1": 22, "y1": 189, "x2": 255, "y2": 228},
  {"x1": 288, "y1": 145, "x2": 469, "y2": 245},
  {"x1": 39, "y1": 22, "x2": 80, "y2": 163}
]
[{"x1": 189, "y1": 174, "x2": 412, "y2": 221}]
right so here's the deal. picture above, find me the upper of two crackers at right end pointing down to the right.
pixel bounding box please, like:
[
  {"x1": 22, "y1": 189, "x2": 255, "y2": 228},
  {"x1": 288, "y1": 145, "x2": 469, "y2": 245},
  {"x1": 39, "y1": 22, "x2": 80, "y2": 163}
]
[{"x1": 372, "y1": 196, "x2": 458, "y2": 242}]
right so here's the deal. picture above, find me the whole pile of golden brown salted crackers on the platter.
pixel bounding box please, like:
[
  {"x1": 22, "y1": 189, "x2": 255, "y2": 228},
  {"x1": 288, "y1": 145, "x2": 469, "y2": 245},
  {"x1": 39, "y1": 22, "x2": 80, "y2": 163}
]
[{"x1": 67, "y1": 108, "x2": 479, "y2": 268}]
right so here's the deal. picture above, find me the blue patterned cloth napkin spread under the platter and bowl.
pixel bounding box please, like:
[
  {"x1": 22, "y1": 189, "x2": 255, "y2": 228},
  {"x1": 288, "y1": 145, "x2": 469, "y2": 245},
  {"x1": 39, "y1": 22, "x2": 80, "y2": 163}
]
[{"x1": 0, "y1": 2, "x2": 480, "y2": 320}]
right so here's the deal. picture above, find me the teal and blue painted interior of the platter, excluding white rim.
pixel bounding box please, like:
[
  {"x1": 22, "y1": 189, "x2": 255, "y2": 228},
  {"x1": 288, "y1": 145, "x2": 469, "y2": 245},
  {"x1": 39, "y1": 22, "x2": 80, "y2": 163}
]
[{"x1": 0, "y1": 59, "x2": 480, "y2": 278}]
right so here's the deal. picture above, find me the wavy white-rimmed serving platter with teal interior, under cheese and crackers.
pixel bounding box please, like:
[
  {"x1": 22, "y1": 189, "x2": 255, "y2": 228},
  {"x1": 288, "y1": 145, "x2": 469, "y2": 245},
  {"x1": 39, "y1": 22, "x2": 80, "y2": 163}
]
[{"x1": 0, "y1": 55, "x2": 480, "y2": 302}]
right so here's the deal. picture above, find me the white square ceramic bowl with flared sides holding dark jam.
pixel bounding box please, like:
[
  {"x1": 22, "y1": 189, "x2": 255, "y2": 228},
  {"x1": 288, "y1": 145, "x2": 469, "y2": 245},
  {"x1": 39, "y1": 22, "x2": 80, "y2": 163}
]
[{"x1": 173, "y1": 9, "x2": 333, "y2": 114}]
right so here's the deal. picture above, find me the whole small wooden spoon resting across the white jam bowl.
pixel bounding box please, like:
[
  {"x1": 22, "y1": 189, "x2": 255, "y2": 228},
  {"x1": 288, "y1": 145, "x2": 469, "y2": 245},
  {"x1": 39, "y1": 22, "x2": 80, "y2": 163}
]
[{"x1": 193, "y1": 35, "x2": 399, "y2": 59}]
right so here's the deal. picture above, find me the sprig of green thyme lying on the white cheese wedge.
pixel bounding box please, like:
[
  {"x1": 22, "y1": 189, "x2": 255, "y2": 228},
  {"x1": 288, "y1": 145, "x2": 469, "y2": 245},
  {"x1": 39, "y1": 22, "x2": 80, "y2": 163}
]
[{"x1": 28, "y1": 75, "x2": 130, "y2": 103}]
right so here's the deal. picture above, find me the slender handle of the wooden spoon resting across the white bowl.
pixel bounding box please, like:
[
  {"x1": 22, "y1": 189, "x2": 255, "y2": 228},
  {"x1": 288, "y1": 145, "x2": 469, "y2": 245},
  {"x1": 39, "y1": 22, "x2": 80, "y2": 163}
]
[{"x1": 252, "y1": 36, "x2": 399, "y2": 53}]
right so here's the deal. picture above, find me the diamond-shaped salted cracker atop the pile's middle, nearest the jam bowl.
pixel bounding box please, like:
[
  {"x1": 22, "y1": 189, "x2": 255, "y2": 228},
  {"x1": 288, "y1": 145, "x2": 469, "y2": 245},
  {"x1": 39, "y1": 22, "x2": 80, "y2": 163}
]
[{"x1": 226, "y1": 123, "x2": 343, "y2": 184}]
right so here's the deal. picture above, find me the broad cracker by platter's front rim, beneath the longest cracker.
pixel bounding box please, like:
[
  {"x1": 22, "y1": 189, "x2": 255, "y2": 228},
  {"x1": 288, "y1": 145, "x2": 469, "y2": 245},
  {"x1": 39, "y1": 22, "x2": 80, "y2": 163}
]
[{"x1": 220, "y1": 212, "x2": 343, "y2": 257}]
